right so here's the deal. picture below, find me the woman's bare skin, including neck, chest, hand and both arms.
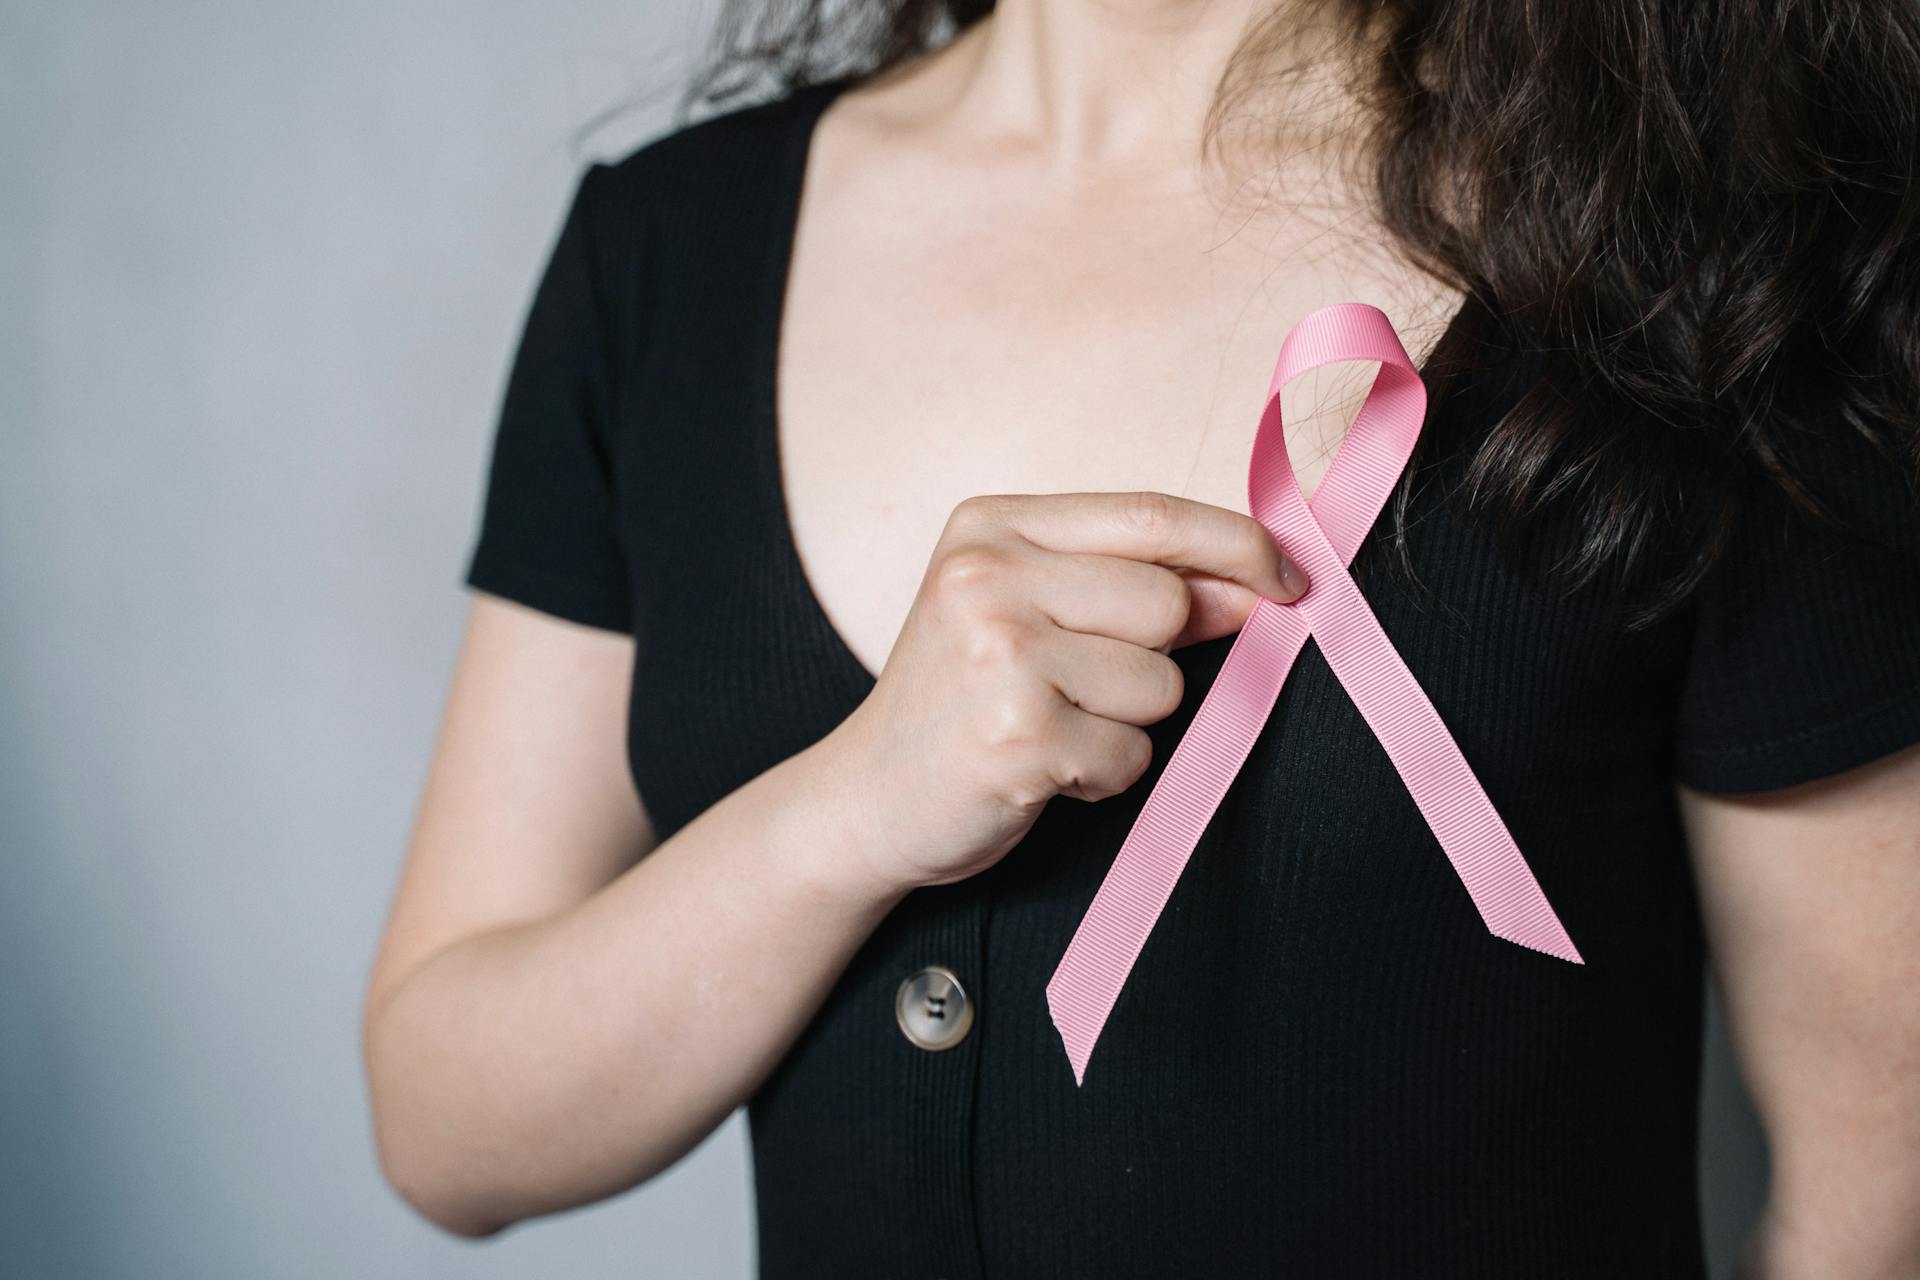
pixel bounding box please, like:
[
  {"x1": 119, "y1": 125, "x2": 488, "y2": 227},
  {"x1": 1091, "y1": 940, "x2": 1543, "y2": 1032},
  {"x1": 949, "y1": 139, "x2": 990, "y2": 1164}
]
[{"x1": 363, "y1": 0, "x2": 1920, "y2": 1258}]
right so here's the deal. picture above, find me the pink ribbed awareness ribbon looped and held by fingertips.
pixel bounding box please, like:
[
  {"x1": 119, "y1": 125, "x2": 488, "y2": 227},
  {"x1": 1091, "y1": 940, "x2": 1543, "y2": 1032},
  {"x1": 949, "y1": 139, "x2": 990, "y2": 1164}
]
[{"x1": 1046, "y1": 303, "x2": 1586, "y2": 1084}]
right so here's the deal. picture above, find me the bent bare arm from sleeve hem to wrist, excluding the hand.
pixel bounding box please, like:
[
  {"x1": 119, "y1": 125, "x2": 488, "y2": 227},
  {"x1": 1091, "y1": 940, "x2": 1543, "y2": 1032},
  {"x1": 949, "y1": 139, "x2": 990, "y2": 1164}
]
[{"x1": 363, "y1": 595, "x2": 904, "y2": 1236}]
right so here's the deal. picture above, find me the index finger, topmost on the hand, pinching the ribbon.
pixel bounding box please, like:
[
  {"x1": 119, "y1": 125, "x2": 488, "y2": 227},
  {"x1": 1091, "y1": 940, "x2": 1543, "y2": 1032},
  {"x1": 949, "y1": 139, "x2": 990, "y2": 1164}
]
[{"x1": 952, "y1": 489, "x2": 1308, "y2": 603}]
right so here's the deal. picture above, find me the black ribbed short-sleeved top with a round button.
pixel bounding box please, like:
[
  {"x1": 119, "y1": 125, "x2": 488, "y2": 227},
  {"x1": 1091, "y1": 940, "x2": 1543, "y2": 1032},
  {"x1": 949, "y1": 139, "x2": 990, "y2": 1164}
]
[{"x1": 468, "y1": 81, "x2": 1920, "y2": 1280}]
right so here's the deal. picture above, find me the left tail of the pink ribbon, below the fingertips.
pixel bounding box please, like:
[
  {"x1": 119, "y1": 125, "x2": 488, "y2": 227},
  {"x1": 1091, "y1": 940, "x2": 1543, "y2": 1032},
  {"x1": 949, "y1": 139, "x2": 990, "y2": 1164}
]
[{"x1": 1046, "y1": 601, "x2": 1308, "y2": 1084}]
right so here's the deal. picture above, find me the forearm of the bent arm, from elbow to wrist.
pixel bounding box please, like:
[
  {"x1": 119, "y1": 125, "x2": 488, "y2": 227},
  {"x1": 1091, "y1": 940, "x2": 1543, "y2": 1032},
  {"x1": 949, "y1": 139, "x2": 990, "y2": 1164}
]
[{"x1": 367, "y1": 729, "x2": 904, "y2": 1234}]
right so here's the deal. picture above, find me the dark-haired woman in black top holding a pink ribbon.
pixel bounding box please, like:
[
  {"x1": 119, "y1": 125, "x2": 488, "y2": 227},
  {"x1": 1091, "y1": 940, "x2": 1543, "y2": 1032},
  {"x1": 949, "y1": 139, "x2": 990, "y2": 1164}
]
[{"x1": 365, "y1": 0, "x2": 1920, "y2": 1280}]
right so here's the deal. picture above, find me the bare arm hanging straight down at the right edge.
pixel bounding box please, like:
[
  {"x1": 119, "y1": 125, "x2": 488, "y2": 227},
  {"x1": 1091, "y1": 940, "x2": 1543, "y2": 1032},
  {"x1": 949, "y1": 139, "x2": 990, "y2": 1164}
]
[{"x1": 1680, "y1": 736, "x2": 1920, "y2": 1280}]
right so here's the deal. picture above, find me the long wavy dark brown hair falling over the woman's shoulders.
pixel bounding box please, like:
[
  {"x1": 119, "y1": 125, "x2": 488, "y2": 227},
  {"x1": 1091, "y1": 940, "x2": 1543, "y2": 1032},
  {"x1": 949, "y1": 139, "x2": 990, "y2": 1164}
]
[{"x1": 680, "y1": 0, "x2": 1920, "y2": 628}]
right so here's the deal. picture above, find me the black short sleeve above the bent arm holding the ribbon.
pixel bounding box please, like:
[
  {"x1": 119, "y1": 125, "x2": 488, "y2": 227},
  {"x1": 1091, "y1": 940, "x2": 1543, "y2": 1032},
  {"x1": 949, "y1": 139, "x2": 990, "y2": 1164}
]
[{"x1": 467, "y1": 161, "x2": 634, "y2": 631}]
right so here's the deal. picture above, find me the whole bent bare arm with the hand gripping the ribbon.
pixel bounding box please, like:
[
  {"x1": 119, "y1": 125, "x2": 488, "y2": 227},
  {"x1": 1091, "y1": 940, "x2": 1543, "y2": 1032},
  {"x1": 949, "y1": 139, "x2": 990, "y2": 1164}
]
[{"x1": 363, "y1": 493, "x2": 1304, "y2": 1236}]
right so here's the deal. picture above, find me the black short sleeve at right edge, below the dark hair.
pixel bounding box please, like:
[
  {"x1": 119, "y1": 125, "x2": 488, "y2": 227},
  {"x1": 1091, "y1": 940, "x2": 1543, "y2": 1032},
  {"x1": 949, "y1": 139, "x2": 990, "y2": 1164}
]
[{"x1": 1674, "y1": 385, "x2": 1920, "y2": 793}]
